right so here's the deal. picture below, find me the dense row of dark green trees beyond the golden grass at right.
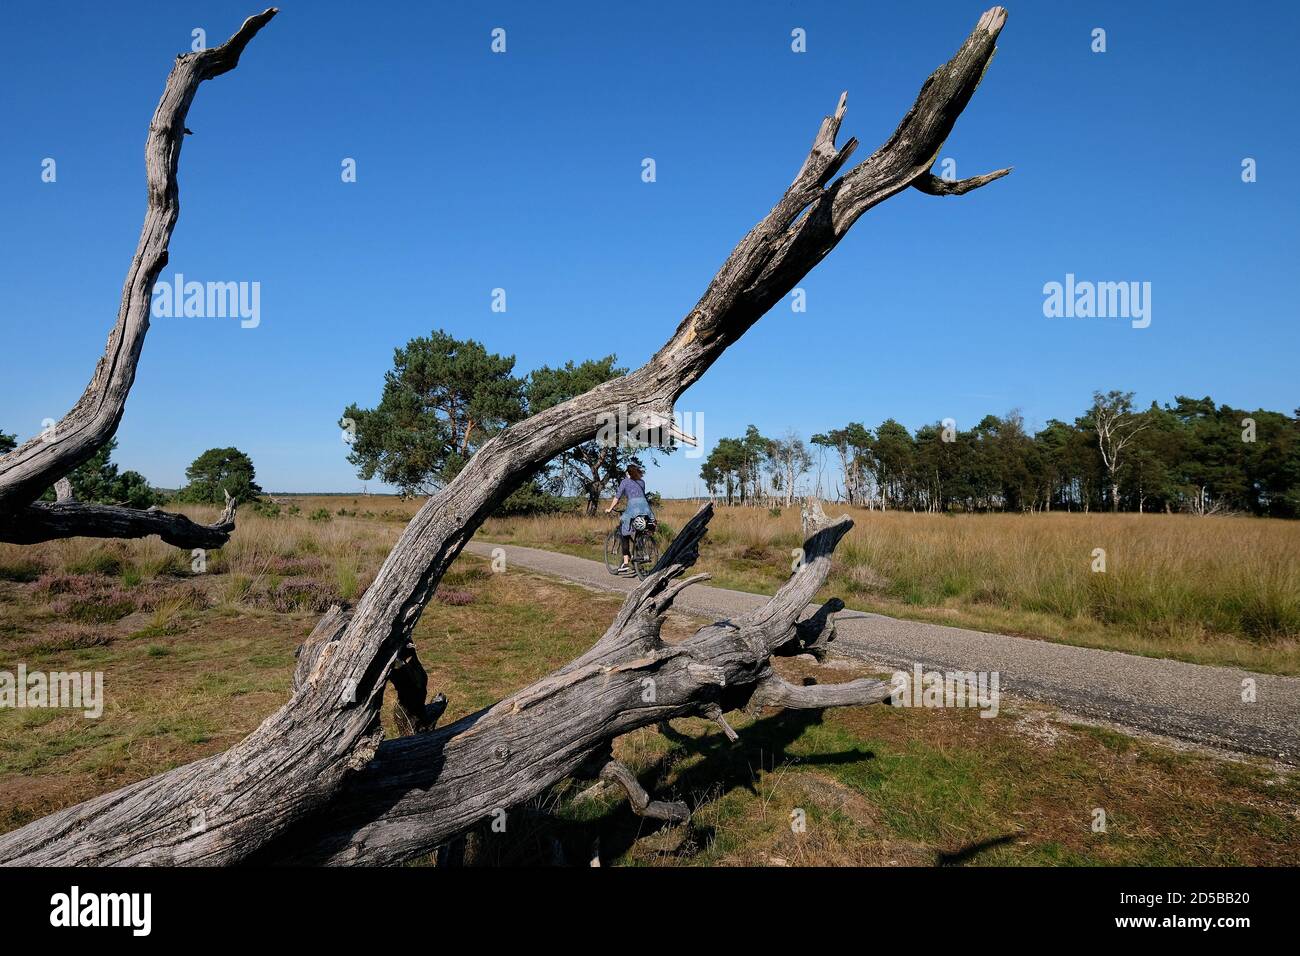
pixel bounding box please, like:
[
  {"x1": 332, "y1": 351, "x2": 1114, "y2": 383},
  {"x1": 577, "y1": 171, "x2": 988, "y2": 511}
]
[{"x1": 699, "y1": 392, "x2": 1300, "y2": 518}]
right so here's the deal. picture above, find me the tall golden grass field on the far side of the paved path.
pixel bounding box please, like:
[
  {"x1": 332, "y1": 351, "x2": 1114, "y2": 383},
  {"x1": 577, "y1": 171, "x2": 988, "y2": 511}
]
[{"x1": 480, "y1": 502, "x2": 1300, "y2": 674}]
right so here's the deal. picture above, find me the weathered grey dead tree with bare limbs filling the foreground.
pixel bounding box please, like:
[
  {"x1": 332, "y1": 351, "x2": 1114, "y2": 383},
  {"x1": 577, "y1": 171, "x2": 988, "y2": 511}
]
[{"x1": 0, "y1": 8, "x2": 1010, "y2": 865}]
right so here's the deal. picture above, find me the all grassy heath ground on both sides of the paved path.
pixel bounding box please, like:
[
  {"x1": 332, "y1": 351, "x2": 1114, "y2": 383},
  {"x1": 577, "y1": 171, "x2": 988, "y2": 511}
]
[{"x1": 0, "y1": 496, "x2": 1300, "y2": 865}]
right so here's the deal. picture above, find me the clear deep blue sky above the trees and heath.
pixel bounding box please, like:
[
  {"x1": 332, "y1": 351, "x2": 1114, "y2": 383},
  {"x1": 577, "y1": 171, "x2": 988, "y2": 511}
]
[{"x1": 0, "y1": 0, "x2": 1300, "y2": 494}]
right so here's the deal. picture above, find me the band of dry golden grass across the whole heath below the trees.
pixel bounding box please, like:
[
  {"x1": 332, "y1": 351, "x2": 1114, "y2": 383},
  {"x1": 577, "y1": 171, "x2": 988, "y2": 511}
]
[{"x1": 0, "y1": 496, "x2": 1300, "y2": 674}]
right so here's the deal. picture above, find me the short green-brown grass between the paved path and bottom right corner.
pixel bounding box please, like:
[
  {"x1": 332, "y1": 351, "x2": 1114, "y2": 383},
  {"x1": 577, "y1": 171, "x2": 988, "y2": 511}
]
[{"x1": 527, "y1": 660, "x2": 1300, "y2": 866}]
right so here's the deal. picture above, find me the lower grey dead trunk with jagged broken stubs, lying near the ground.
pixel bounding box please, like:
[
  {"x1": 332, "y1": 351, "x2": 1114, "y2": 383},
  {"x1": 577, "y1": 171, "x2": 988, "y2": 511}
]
[{"x1": 254, "y1": 505, "x2": 891, "y2": 865}]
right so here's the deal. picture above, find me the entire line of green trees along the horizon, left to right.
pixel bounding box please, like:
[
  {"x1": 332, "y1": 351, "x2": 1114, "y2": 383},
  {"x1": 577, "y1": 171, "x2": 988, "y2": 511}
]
[{"x1": 15, "y1": 364, "x2": 1300, "y2": 518}]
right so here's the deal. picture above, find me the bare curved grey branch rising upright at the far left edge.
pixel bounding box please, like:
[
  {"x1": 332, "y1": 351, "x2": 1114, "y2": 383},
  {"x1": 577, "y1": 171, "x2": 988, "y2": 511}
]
[{"x1": 0, "y1": 7, "x2": 277, "y2": 515}]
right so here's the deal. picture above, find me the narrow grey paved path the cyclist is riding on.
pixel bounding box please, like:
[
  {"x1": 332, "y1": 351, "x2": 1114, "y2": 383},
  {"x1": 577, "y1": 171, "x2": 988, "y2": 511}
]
[{"x1": 467, "y1": 540, "x2": 1300, "y2": 765}]
